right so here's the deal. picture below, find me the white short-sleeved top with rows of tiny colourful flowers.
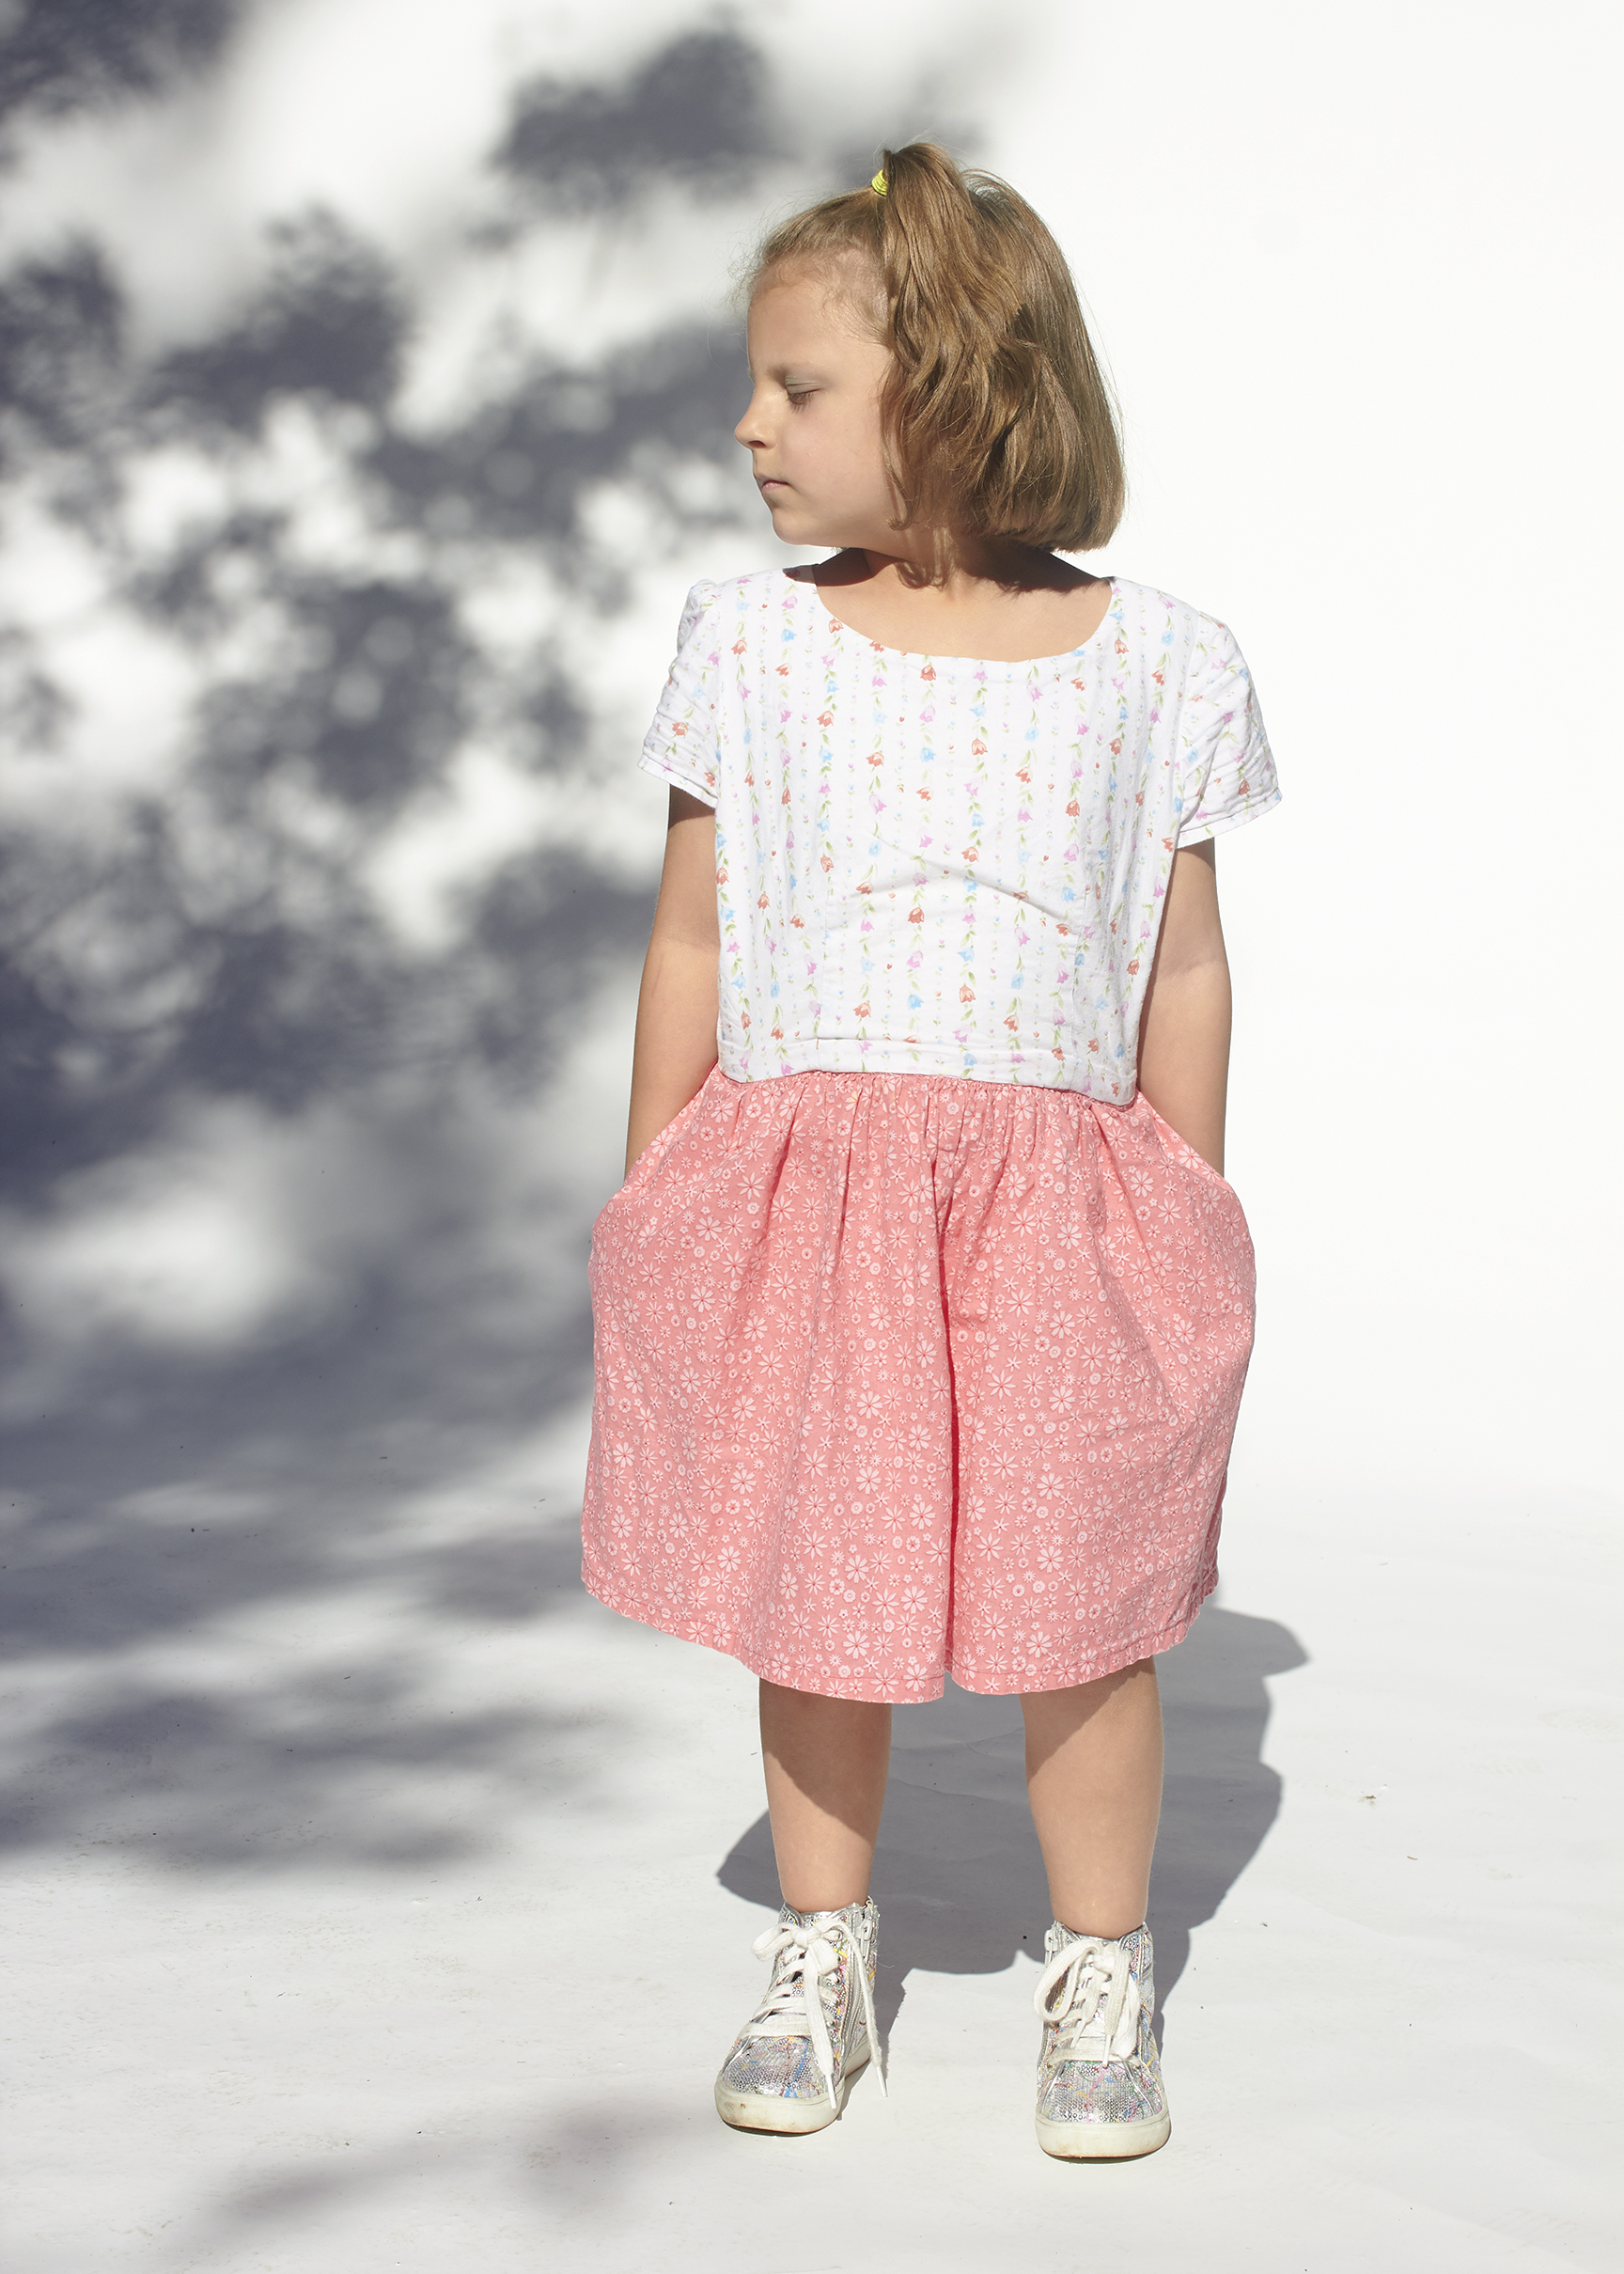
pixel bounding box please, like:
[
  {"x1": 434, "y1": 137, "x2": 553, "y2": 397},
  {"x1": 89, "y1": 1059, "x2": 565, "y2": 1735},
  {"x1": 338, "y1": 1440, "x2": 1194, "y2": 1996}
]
[{"x1": 641, "y1": 571, "x2": 1281, "y2": 1106}]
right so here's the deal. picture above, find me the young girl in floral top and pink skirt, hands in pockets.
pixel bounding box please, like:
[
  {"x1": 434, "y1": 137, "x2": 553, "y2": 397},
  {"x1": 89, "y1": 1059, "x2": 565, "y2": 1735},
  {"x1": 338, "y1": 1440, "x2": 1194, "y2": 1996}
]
[{"x1": 585, "y1": 143, "x2": 1278, "y2": 2158}]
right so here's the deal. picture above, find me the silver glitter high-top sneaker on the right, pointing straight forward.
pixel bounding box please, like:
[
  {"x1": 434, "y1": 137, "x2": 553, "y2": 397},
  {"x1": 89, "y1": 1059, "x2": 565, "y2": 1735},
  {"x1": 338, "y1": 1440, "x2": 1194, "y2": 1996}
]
[{"x1": 1033, "y1": 1920, "x2": 1174, "y2": 2160}]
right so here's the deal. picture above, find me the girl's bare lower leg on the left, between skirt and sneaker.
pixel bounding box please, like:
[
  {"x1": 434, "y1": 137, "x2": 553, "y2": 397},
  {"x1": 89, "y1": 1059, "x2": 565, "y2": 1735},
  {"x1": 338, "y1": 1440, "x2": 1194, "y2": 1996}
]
[{"x1": 762, "y1": 1683, "x2": 886, "y2": 1923}]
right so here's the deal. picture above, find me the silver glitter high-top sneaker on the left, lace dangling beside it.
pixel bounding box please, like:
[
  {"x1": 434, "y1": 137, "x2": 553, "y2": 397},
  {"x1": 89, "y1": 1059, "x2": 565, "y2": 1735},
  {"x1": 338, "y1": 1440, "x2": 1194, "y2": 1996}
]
[{"x1": 716, "y1": 1904, "x2": 884, "y2": 2133}]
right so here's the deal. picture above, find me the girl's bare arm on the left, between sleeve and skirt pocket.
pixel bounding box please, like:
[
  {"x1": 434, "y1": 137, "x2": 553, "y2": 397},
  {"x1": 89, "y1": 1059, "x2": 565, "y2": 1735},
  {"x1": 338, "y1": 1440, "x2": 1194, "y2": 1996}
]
[{"x1": 626, "y1": 789, "x2": 721, "y2": 1171}]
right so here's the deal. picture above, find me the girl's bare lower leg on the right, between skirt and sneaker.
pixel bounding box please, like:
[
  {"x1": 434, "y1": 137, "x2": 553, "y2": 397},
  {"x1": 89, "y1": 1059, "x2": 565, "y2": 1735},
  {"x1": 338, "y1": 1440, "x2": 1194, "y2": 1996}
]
[{"x1": 1022, "y1": 1657, "x2": 1163, "y2": 1936}]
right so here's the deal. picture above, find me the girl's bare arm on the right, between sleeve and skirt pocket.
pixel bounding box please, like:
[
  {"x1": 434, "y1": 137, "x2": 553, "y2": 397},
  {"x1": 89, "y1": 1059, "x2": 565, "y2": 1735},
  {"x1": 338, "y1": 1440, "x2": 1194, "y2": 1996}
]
[{"x1": 1140, "y1": 839, "x2": 1230, "y2": 1176}]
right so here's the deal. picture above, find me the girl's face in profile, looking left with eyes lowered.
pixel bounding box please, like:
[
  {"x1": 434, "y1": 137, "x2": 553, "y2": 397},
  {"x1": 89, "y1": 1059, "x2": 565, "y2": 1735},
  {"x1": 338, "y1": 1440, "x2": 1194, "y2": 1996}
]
[{"x1": 732, "y1": 268, "x2": 898, "y2": 555}]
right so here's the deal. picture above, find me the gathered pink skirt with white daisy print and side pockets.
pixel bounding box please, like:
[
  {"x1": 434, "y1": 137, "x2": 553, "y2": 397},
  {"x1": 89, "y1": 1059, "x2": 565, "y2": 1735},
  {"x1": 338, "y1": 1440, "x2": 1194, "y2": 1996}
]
[{"x1": 583, "y1": 1071, "x2": 1254, "y2": 1703}]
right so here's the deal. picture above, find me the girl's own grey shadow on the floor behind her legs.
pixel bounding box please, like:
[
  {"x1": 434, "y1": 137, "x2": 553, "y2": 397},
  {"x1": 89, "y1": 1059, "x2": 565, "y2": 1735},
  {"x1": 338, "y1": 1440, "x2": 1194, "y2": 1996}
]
[{"x1": 716, "y1": 1606, "x2": 1308, "y2": 2040}]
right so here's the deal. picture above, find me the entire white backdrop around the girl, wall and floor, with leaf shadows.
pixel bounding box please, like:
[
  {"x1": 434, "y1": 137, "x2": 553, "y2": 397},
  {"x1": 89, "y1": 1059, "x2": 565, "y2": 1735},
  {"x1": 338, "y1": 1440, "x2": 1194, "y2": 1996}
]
[{"x1": 0, "y1": 0, "x2": 1624, "y2": 2274}]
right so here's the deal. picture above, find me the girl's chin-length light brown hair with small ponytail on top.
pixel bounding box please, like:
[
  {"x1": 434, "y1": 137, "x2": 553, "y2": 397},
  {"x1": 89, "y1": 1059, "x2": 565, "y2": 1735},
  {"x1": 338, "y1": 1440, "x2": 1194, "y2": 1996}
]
[{"x1": 748, "y1": 141, "x2": 1126, "y2": 553}]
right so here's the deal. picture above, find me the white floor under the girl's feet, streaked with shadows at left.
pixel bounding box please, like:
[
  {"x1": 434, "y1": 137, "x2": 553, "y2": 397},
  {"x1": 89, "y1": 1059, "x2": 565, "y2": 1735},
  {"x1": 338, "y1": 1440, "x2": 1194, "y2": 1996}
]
[{"x1": 2, "y1": 1415, "x2": 1624, "y2": 2274}]
